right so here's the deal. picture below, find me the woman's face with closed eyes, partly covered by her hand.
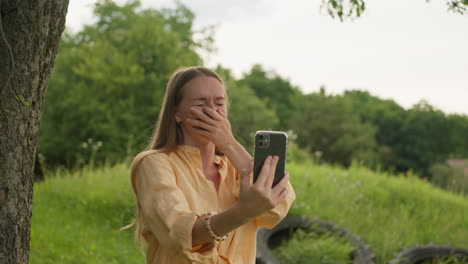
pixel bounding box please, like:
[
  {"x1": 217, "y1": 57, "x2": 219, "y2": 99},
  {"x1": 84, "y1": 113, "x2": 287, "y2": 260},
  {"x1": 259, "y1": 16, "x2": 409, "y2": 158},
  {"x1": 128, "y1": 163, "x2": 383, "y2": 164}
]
[{"x1": 175, "y1": 75, "x2": 227, "y2": 144}]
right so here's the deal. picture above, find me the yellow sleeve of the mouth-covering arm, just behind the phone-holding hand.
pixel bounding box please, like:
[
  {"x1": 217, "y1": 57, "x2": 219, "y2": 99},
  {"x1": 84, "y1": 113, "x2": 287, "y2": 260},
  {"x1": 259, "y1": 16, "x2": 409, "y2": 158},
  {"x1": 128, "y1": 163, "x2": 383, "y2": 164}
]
[{"x1": 255, "y1": 182, "x2": 296, "y2": 229}]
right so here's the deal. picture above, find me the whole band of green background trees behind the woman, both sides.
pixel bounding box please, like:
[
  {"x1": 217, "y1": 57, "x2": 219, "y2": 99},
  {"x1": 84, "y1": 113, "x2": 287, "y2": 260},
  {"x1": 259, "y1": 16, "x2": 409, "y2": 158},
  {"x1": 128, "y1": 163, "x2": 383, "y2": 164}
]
[{"x1": 39, "y1": 0, "x2": 468, "y2": 179}]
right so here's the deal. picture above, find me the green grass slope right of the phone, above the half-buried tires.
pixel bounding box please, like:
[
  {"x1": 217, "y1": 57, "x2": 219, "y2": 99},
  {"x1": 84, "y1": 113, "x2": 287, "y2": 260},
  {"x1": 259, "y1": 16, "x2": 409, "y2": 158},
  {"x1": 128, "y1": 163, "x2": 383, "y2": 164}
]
[{"x1": 289, "y1": 162, "x2": 468, "y2": 263}]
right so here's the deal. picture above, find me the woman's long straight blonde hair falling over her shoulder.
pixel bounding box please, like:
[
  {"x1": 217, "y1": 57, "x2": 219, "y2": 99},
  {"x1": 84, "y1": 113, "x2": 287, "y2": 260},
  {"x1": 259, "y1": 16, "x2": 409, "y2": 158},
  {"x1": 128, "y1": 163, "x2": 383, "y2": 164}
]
[{"x1": 120, "y1": 66, "x2": 227, "y2": 247}]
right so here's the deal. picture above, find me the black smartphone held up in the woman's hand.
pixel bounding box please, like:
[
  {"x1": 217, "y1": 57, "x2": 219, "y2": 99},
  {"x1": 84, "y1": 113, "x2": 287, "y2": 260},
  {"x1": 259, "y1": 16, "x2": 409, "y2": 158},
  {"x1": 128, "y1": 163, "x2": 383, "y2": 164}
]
[{"x1": 253, "y1": 130, "x2": 288, "y2": 186}]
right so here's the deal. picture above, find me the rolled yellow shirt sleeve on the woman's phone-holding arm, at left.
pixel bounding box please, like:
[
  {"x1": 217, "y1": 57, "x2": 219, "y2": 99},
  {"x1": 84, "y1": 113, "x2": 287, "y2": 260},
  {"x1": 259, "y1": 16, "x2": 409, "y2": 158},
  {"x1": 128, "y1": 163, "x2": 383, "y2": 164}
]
[{"x1": 135, "y1": 153, "x2": 217, "y2": 263}]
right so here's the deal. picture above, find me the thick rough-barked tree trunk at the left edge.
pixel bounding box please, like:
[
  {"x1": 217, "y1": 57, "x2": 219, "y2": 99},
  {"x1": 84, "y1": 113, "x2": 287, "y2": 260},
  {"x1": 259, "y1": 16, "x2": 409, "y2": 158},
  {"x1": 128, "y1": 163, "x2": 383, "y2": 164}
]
[{"x1": 0, "y1": 0, "x2": 68, "y2": 264}]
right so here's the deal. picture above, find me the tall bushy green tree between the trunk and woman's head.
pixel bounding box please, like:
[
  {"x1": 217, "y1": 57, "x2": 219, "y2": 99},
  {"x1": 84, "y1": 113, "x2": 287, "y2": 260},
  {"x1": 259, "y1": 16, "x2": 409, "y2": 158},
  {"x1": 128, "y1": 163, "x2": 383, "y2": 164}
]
[{"x1": 39, "y1": 0, "x2": 206, "y2": 165}]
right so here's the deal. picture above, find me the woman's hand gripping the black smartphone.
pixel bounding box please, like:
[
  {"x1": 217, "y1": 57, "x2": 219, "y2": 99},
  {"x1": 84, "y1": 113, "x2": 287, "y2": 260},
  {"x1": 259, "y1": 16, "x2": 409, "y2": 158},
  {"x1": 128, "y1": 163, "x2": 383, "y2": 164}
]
[{"x1": 236, "y1": 156, "x2": 289, "y2": 219}]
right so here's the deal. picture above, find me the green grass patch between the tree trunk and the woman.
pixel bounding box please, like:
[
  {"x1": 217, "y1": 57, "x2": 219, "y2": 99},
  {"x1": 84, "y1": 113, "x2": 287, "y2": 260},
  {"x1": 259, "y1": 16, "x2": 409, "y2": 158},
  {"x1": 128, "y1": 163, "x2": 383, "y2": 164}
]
[{"x1": 30, "y1": 165, "x2": 145, "y2": 264}]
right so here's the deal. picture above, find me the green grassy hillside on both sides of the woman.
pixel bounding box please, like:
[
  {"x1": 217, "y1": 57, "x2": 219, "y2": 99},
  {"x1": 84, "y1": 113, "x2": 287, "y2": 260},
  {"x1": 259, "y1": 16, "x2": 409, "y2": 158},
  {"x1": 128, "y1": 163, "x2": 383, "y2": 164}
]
[{"x1": 30, "y1": 160, "x2": 468, "y2": 264}]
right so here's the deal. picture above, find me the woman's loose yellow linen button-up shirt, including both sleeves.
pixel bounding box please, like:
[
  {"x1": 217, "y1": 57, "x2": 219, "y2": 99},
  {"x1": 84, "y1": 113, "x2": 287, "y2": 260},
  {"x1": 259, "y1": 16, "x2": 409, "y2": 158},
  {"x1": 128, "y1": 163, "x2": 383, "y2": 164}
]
[{"x1": 132, "y1": 145, "x2": 295, "y2": 264}]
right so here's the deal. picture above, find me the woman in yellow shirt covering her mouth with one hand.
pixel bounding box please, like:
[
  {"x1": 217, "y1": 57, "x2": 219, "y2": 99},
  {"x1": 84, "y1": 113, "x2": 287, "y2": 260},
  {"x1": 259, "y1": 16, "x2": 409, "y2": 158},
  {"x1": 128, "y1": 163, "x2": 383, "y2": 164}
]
[{"x1": 127, "y1": 67, "x2": 295, "y2": 264}]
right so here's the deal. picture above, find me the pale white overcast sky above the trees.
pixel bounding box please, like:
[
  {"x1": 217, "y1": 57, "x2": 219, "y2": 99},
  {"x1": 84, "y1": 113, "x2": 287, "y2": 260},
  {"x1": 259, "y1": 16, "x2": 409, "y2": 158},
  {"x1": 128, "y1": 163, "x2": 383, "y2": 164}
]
[{"x1": 67, "y1": 0, "x2": 468, "y2": 114}]
